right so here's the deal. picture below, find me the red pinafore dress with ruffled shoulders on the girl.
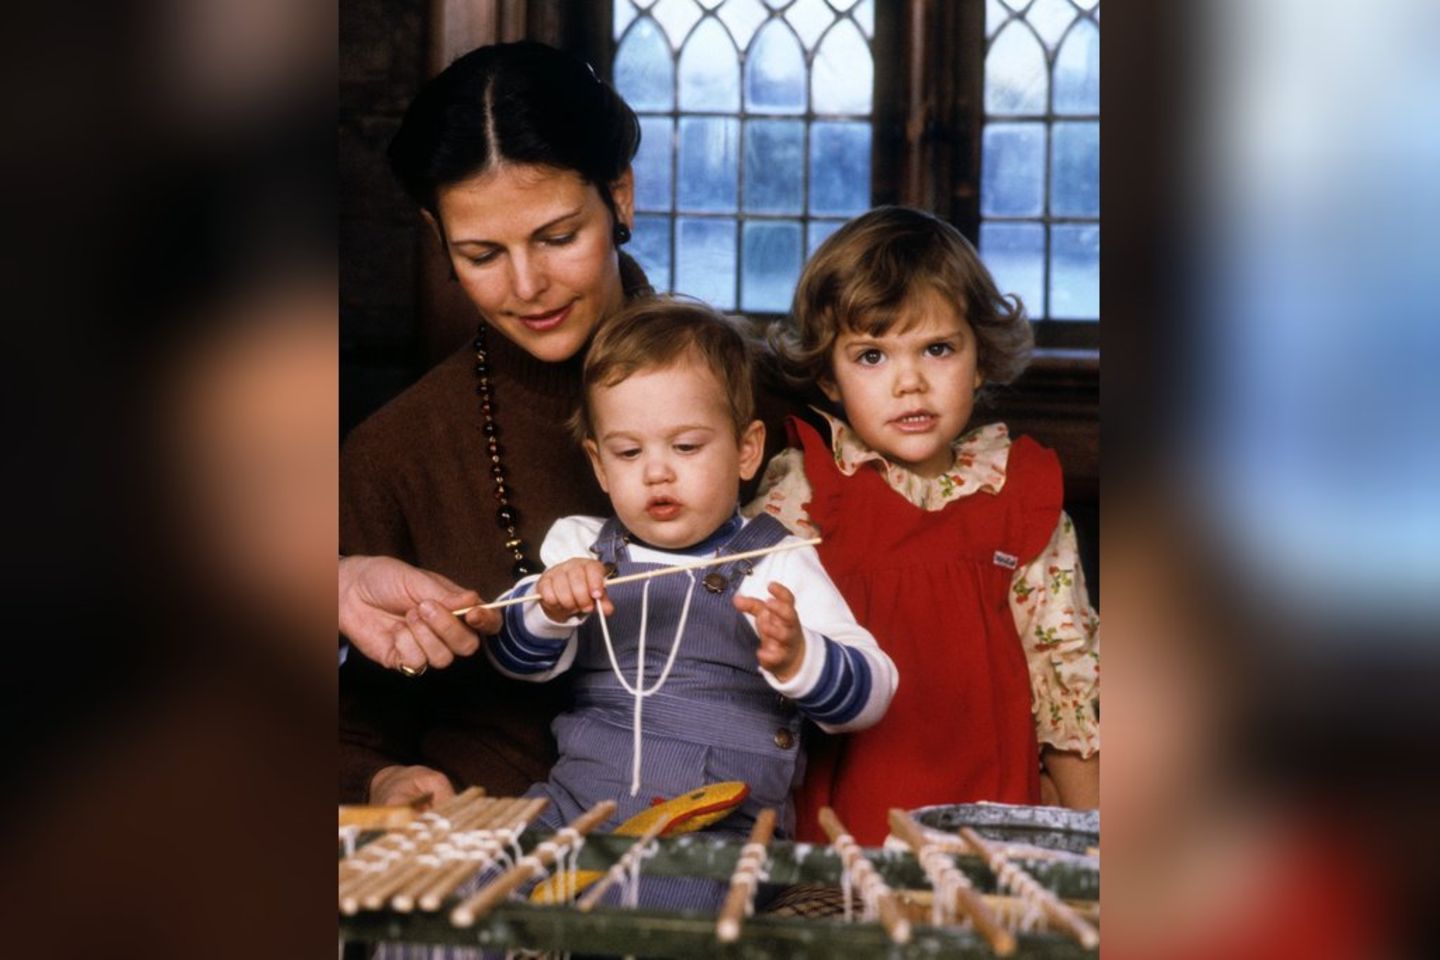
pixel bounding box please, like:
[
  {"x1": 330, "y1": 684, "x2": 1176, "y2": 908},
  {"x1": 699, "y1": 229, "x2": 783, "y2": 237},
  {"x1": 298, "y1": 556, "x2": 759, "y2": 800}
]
[{"x1": 789, "y1": 417, "x2": 1063, "y2": 846}]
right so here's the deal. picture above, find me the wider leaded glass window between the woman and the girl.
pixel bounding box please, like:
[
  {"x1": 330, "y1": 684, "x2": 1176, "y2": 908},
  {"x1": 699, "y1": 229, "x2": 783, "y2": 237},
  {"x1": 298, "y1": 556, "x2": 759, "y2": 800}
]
[{"x1": 613, "y1": 0, "x2": 874, "y2": 312}]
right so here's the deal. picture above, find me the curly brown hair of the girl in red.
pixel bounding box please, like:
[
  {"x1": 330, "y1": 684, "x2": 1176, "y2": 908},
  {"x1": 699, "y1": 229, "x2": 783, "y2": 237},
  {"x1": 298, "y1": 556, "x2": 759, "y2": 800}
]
[{"x1": 766, "y1": 206, "x2": 1034, "y2": 394}]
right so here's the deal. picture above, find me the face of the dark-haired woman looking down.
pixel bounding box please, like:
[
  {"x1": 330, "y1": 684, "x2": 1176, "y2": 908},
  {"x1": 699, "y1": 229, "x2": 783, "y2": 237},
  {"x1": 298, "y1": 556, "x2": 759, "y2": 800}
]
[{"x1": 426, "y1": 164, "x2": 635, "y2": 363}]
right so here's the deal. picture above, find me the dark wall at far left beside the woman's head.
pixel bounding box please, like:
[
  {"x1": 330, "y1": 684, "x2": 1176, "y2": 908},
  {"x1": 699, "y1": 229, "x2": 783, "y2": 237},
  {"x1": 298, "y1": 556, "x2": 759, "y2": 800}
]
[{"x1": 338, "y1": 0, "x2": 428, "y2": 435}]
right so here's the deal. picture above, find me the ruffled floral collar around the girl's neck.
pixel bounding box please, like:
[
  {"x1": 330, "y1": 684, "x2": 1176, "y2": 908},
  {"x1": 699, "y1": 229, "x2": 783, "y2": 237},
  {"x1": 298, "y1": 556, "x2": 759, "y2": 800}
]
[{"x1": 815, "y1": 409, "x2": 1009, "y2": 510}]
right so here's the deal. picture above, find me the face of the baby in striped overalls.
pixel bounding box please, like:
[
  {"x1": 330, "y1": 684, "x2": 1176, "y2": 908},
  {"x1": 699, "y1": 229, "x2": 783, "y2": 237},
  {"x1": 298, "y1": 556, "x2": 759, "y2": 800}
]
[{"x1": 585, "y1": 357, "x2": 765, "y2": 548}]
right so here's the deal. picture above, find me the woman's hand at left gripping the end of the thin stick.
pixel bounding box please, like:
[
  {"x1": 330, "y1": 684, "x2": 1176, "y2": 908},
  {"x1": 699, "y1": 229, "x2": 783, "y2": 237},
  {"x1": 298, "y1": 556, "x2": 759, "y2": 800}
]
[{"x1": 340, "y1": 557, "x2": 501, "y2": 671}]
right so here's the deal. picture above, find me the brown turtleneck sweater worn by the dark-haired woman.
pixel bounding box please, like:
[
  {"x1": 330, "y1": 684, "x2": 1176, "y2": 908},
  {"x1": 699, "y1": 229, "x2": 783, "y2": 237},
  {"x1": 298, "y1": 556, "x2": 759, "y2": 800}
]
[{"x1": 340, "y1": 258, "x2": 785, "y2": 803}]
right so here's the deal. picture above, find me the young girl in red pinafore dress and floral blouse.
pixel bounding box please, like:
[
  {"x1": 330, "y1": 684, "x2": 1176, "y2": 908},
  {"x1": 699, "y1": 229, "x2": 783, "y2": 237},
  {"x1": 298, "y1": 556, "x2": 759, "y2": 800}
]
[{"x1": 746, "y1": 207, "x2": 1100, "y2": 843}]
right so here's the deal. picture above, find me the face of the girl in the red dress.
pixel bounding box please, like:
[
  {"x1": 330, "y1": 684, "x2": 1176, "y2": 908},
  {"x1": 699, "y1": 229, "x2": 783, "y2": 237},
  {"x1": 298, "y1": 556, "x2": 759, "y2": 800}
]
[{"x1": 821, "y1": 288, "x2": 982, "y2": 476}]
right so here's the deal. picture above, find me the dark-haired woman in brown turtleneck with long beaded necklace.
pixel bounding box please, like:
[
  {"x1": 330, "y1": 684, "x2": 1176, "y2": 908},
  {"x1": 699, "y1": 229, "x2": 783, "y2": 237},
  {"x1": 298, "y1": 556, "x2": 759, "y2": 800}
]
[{"x1": 340, "y1": 43, "x2": 662, "y2": 803}]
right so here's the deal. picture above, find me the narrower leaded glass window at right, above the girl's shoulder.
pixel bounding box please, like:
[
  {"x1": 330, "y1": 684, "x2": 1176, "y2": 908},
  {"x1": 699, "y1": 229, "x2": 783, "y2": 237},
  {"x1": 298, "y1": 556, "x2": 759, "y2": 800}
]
[{"x1": 979, "y1": 0, "x2": 1100, "y2": 321}]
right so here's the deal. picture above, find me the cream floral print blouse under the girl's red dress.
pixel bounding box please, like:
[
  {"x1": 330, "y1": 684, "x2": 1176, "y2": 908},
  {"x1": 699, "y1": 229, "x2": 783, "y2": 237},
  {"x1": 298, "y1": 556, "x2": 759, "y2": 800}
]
[{"x1": 742, "y1": 413, "x2": 1100, "y2": 757}]
